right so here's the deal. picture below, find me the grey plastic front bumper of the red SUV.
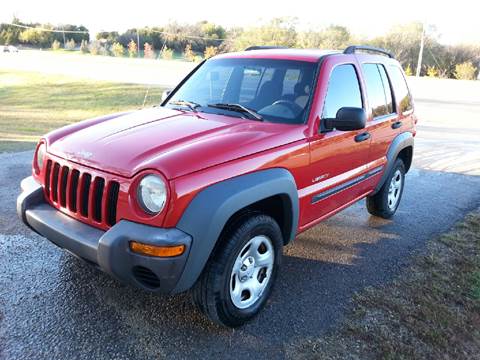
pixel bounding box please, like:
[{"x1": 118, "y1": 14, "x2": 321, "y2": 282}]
[{"x1": 17, "y1": 177, "x2": 192, "y2": 294}]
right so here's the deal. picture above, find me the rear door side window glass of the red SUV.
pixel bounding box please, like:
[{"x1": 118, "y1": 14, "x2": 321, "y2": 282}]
[{"x1": 362, "y1": 64, "x2": 393, "y2": 118}]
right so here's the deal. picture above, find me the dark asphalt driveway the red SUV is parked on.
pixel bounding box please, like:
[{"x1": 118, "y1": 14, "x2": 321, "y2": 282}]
[{"x1": 0, "y1": 95, "x2": 480, "y2": 359}]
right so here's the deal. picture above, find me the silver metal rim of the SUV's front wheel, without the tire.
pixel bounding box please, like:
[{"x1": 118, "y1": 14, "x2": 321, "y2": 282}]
[{"x1": 230, "y1": 235, "x2": 275, "y2": 309}]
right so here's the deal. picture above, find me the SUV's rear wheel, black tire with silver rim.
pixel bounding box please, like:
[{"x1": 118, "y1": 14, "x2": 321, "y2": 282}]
[{"x1": 367, "y1": 159, "x2": 405, "y2": 219}]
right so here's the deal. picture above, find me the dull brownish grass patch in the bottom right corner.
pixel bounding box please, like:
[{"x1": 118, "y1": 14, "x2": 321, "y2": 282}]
[{"x1": 288, "y1": 211, "x2": 480, "y2": 359}]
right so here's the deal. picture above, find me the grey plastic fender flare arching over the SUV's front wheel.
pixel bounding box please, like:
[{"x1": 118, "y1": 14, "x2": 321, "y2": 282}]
[{"x1": 173, "y1": 168, "x2": 299, "y2": 293}]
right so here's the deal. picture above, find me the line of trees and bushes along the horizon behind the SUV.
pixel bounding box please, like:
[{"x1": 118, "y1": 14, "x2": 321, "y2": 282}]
[{"x1": 0, "y1": 18, "x2": 480, "y2": 79}]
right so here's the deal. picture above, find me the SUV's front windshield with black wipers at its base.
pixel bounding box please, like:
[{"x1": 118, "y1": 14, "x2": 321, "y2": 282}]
[{"x1": 166, "y1": 58, "x2": 317, "y2": 124}]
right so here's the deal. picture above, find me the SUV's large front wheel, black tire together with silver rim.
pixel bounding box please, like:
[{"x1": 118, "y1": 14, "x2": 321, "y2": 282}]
[{"x1": 192, "y1": 215, "x2": 283, "y2": 327}]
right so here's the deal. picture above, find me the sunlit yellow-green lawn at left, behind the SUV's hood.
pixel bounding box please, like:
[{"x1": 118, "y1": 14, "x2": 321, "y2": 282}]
[{"x1": 0, "y1": 70, "x2": 163, "y2": 152}]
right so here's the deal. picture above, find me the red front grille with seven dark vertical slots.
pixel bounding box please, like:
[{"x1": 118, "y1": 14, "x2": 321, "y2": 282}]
[{"x1": 44, "y1": 159, "x2": 120, "y2": 227}]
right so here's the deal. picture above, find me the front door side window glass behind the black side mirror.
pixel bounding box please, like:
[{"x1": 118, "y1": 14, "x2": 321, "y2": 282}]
[{"x1": 322, "y1": 65, "x2": 362, "y2": 119}]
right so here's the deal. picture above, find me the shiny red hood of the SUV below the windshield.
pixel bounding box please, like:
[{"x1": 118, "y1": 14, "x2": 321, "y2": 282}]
[{"x1": 46, "y1": 107, "x2": 305, "y2": 179}]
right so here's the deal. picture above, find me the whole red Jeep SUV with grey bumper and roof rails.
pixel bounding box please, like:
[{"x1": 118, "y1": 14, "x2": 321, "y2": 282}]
[{"x1": 17, "y1": 46, "x2": 416, "y2": 326}]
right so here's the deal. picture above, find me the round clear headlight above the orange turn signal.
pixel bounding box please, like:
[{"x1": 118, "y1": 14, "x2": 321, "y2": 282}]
[{"x1": 137, "y1": 175, "x2": 167, "y2": 214}]
